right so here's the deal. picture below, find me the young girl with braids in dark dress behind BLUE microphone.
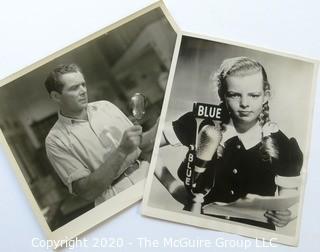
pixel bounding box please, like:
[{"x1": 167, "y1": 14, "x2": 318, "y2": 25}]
[{"x1": 155, "y1": 57, "x2": 303, "y2": 229}]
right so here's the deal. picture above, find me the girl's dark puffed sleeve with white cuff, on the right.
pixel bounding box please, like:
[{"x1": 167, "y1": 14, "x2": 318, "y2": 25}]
[{"x1": 275, "y1": 131, "x2": 303, "y2": 188}]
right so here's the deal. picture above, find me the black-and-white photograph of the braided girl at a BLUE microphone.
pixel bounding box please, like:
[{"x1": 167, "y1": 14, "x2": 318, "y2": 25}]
[{"x1": 143, "y1": 34, "x2": 316, "y2": 245}]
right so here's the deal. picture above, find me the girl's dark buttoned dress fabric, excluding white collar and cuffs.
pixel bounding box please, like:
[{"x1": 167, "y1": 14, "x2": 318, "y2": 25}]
[{"x1": 172, "y1": 113, "x2": 303, "y2": 229}]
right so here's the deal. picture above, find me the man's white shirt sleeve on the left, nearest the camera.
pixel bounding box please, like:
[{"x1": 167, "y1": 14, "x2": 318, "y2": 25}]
[{"x1": 46, "y1": 138, "x2": 91, "y2": 193}]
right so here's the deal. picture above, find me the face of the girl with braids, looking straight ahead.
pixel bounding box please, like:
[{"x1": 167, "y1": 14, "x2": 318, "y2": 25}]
[{"x1": 225, "y1": 72, "x2": 269, "y2": 129}]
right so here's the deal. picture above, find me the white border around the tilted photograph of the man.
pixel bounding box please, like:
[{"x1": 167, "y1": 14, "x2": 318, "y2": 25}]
[{"x1": 0, "y1": 1, "x2": 180, "y2": 246}]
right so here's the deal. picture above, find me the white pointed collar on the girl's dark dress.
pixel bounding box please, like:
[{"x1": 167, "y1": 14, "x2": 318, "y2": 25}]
[{"x1": 221, "y1": 120, "x2": 262, "y2": 149}]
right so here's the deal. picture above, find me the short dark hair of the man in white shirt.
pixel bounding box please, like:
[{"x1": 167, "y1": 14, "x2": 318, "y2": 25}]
[{"x1": 44, "y1": 63, "x2": 82, "y2": 94}]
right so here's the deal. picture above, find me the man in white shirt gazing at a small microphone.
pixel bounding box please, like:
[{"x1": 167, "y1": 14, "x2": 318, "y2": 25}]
[{"x1": 45, "y1": 64, "x2": 157, "y2": 205}]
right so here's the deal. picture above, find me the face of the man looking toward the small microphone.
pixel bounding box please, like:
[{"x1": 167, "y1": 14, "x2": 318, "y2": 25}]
[{"x1": 59, "y1": 72, "x2": 88, "y2": 114}]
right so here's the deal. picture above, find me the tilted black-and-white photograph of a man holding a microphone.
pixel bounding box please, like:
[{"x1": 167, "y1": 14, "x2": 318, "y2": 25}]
[{"x1": 0, "y1": 3, "x2": 177, "y2": 242}]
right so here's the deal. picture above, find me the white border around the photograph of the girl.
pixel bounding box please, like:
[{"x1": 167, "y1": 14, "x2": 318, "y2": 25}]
[{"x1": 141, "y1": 31, "x2": 319, "y2": 246}]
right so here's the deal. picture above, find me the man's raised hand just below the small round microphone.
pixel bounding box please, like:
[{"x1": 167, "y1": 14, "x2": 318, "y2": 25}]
[{"x1": 119, "y1": 125, "x2": 142, "y2": 155}]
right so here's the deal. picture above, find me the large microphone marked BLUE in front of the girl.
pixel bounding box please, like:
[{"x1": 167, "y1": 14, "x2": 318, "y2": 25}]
[{"x1": 184, "y1": 102, "x2": 224, "y2": 214}]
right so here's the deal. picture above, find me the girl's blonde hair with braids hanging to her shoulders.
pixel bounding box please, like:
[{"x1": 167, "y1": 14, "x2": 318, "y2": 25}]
[{"x1": 213, "y1": 57, "x2": 279, "y2": 161}]
